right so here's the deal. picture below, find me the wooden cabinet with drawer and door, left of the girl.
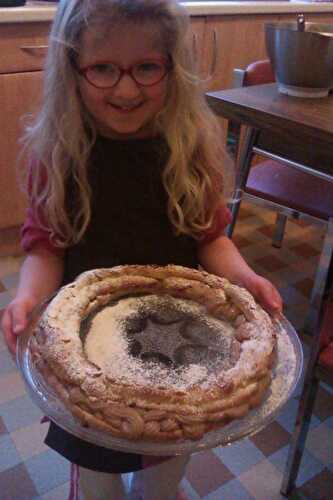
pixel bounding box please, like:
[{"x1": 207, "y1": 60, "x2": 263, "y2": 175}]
[{"x1": 0, "y1": 23, "x2": 49, "y2": 231}]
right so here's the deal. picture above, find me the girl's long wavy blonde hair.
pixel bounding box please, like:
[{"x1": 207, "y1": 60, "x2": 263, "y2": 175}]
[{"x1": 25, "y1": 0, "x2": 232, "y2": 247}]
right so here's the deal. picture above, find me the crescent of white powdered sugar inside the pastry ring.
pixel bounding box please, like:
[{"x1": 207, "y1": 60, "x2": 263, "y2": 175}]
[{"x1": 84, "y1": 295, "x2": 234, "y2": 390}]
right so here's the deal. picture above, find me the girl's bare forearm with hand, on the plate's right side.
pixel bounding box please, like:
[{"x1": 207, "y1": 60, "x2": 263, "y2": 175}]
[{"x1": 198, "y1": 236, "x2": 282, "y2": 313}]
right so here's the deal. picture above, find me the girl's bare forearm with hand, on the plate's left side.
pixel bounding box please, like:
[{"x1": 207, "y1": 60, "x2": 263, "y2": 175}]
[{"x1": 2, "y1": 247, "x2": 63, "y2": 354}]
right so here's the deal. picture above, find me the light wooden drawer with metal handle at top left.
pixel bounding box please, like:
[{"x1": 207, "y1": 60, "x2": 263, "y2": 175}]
[{"x1": 0, "y1": 22, "x2": 51, "y2": 73}]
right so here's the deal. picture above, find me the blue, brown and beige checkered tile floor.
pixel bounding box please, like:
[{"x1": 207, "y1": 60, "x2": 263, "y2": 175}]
[{"x1": 0, "y1": 205, "x2": 333, "y2": 500}]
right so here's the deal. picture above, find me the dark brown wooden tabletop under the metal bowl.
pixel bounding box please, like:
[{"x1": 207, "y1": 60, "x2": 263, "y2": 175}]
[{"x1": 207, "y1": 83, "x2": 333, "y2": 180}]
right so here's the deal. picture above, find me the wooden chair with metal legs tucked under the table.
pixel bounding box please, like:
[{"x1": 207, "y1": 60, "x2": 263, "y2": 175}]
[{"x1": 227, "y1": 60, "x2": 333, "y2": 334}]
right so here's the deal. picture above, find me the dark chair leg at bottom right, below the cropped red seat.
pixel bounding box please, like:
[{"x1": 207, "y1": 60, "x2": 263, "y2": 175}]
[{"x1": 281, "y1": 374, "x2": 319, "y2": 496}]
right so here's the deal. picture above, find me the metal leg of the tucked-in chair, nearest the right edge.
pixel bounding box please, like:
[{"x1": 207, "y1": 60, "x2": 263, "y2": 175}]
[{"x1": 304, "y1": 217, "x2": 333, "y2": 335}]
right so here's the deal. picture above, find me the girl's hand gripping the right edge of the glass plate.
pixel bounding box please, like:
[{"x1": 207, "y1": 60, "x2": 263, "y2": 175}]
[{"x1": 245, "y1": 273, "x2": 283, "y2": 315}]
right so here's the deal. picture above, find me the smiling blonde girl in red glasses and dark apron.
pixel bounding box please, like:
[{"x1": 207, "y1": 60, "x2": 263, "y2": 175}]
[{"x1": 3, "y1": 0, "x2": 282, "y2": 500}]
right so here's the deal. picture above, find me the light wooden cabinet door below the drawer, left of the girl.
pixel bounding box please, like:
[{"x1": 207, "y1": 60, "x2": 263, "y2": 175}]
[{"x1": 0, "y1": 71, "x2": 43, "y2": 229}]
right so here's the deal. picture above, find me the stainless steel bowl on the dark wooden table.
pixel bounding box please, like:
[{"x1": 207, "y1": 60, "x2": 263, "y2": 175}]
[{"x1": 265, "y1": 22, "x2": 333, "y2": 97}]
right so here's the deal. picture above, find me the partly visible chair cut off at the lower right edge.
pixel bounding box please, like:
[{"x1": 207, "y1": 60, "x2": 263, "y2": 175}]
[{"x1": 281, "y1": 296, "x2": 333, "y2": 498}]
